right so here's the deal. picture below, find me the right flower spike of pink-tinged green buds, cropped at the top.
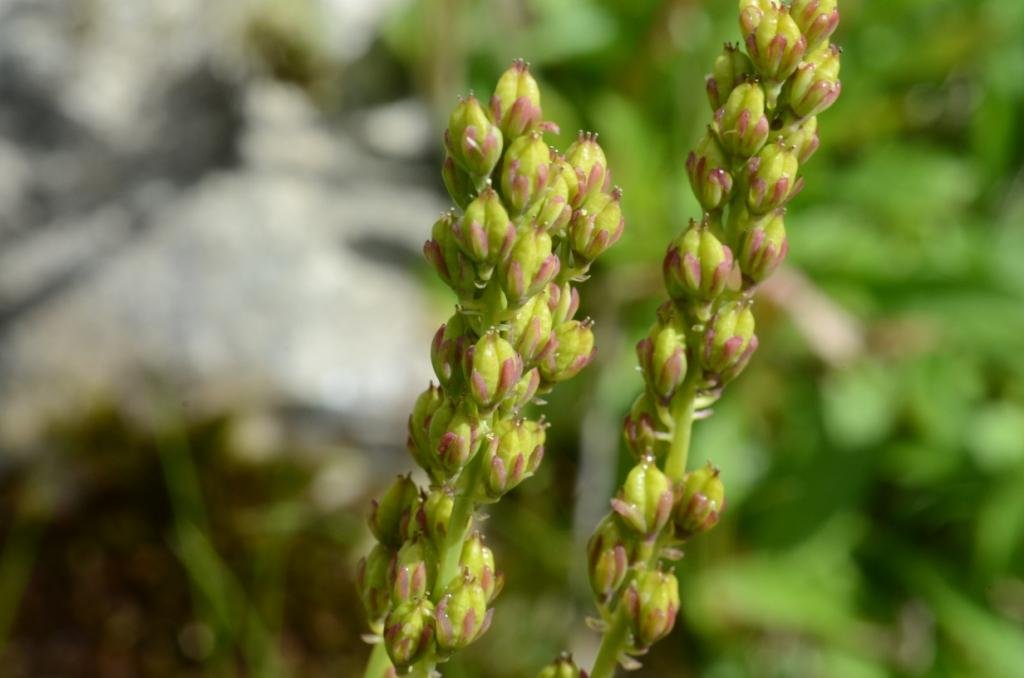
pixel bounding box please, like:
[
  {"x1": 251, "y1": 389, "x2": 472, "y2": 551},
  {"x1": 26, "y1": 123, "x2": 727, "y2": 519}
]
[{"x1": 588, "y1": 0, "x2": 841, "y2": 678}]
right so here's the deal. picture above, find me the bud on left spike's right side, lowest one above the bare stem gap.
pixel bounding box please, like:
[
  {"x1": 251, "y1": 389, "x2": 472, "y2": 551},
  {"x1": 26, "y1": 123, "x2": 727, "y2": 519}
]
[{"x1": 483, "y1": 419, "x2": 545, "y2": 499}]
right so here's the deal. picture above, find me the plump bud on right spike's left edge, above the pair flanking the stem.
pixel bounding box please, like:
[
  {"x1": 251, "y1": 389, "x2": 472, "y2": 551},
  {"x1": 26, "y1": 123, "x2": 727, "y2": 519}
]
[{"x1": 663, "y1": 219, "x2": 733, "y2": 302}]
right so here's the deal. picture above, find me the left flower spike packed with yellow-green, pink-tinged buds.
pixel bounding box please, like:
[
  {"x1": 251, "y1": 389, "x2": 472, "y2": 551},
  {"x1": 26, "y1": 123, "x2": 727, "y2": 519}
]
[{"x1": 359, "y1": 60, "x2": 624, "y2": 672}]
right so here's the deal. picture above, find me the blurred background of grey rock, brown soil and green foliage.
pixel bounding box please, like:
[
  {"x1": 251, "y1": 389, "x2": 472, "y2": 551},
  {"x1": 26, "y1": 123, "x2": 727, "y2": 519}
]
[{"x1": 0, "y1": 0, "x2": 1024, "y2": 678}]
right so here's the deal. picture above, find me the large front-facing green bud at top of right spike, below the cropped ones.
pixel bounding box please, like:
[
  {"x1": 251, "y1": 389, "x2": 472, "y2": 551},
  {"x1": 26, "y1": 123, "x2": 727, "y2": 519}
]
[{"x1": 739, "y1": 0, "x2": 807, "y2": 83}]
